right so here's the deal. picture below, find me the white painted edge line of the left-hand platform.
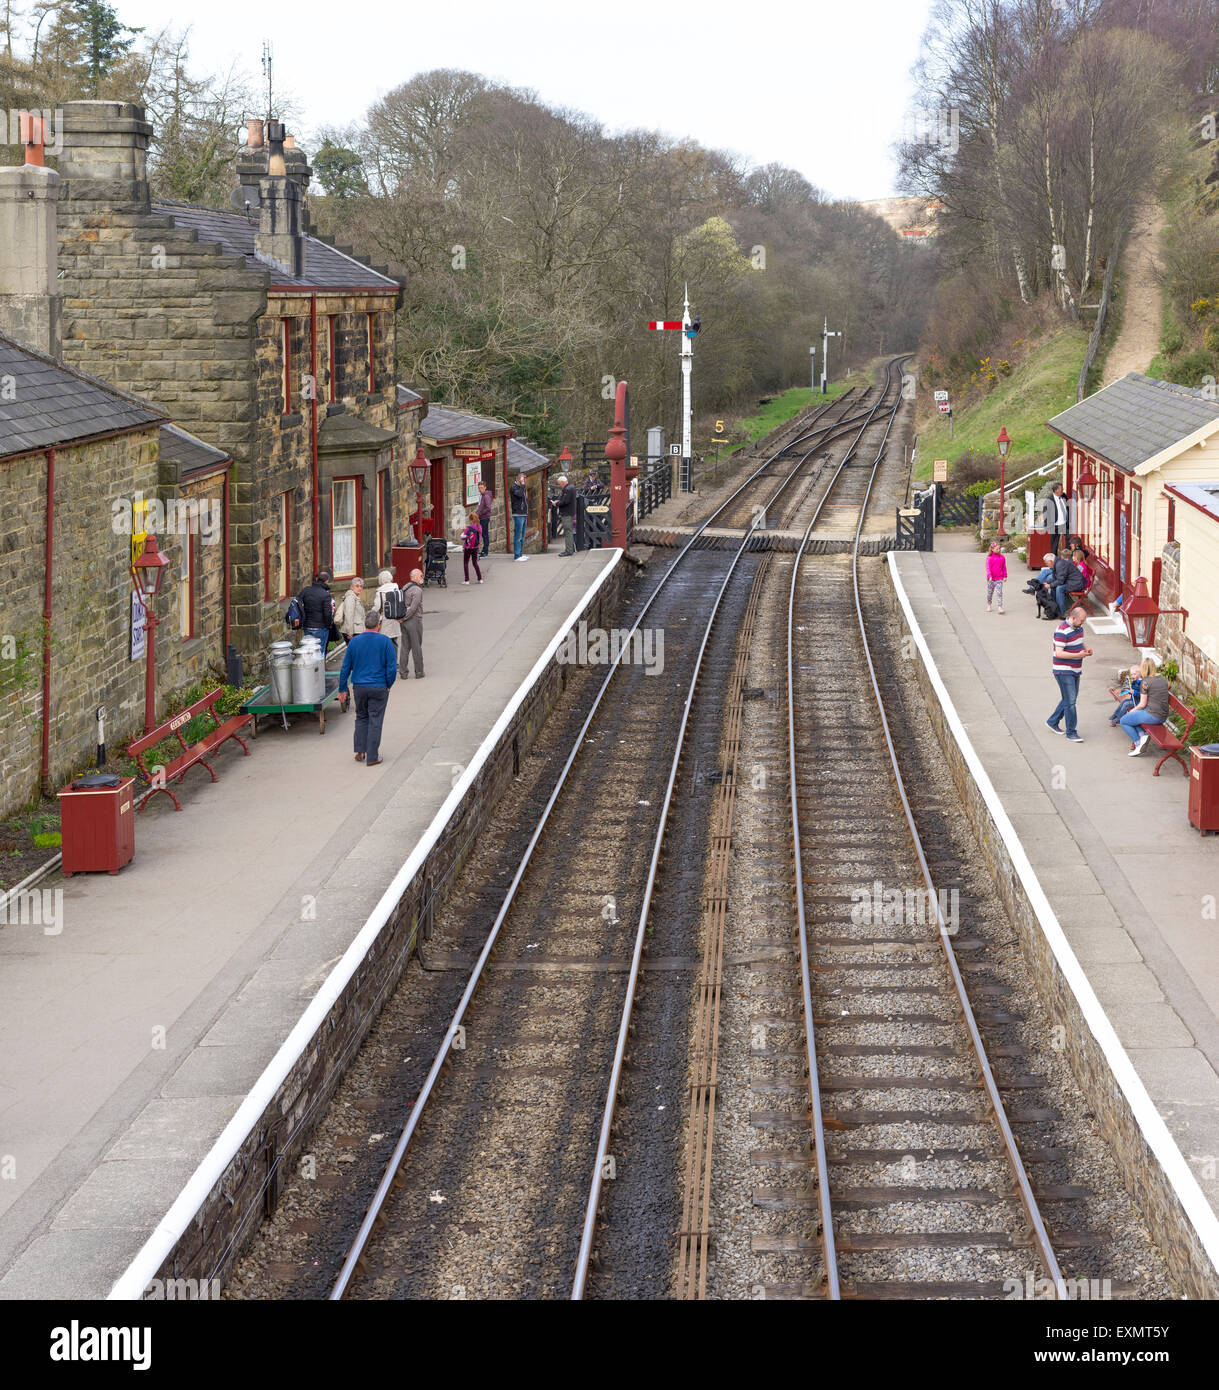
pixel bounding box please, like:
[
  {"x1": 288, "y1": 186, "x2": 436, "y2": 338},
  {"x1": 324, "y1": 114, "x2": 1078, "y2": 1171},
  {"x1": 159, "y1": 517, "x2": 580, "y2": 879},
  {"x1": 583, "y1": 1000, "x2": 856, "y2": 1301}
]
[{"x1": 107, "y1": 550, "x2": 623, "y2": 1300}]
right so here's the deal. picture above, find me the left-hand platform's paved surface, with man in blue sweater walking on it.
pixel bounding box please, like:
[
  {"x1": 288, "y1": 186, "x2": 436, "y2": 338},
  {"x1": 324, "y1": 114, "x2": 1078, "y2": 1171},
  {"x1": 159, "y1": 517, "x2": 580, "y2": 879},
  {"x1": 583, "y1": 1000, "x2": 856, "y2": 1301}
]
[{"x1": 0, "y1": 550, "x2": 620, "y2": 1298}]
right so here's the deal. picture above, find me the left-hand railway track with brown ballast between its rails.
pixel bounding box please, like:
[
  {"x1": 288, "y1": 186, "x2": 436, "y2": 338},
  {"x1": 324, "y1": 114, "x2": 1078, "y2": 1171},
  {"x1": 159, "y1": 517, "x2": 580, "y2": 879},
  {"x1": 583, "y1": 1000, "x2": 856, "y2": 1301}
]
[{"x1": 331, "y1": 364, "x2": 900, "y2": 1300}]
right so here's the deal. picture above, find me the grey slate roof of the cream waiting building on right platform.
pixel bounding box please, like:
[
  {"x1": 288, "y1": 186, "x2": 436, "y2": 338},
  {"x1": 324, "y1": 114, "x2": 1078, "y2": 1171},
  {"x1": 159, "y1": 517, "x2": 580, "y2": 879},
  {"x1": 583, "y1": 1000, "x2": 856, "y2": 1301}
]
[{"x1": 1049, "y1": 371, "x2": 1219, "y2": 473}]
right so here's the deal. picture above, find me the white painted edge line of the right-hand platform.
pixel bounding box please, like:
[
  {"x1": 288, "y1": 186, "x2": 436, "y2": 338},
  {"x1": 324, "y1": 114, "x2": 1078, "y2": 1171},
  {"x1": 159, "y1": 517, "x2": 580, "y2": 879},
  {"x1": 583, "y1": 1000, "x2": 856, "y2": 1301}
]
[{"x1": 888, "y1": 550, "x2": 1219, "y2": 1270}]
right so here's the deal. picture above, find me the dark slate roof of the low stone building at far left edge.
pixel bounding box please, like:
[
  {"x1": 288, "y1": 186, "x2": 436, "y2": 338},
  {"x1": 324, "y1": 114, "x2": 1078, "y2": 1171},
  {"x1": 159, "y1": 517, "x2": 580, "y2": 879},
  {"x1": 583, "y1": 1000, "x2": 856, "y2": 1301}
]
[{"x1": 0, "y1": 338, "x2": 165, "y2": 457}]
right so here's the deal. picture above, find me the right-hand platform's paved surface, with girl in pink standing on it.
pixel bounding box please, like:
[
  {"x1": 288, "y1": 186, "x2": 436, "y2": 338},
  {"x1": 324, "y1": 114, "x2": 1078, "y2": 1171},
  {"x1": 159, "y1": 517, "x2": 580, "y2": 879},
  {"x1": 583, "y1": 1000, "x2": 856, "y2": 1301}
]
[{"x1": 894, "y1": 537, "x2": 1219, "y2": 1212}]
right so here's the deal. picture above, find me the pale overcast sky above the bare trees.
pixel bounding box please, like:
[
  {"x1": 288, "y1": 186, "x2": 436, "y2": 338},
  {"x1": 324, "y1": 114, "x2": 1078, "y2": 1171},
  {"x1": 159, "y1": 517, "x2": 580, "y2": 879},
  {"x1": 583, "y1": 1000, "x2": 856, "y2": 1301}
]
[{"x1": 113, "y1": 0, "x2": 931, "y2": 199}]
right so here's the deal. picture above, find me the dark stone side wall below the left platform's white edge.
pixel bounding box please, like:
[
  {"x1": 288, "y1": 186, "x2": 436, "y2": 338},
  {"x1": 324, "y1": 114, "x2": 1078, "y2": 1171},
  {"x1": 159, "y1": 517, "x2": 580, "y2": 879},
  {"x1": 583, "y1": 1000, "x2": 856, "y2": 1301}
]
[{"x1": 133, "y1": 563, "x2": 627, "y2": 1280}]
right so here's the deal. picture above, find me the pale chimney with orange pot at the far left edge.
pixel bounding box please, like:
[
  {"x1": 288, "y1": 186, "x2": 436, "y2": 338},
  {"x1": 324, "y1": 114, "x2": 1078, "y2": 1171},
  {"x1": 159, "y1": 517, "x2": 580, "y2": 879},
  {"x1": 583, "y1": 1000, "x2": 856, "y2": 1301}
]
[{"x1": 0, "y1": 121, "x2": 63, "y2": 360}]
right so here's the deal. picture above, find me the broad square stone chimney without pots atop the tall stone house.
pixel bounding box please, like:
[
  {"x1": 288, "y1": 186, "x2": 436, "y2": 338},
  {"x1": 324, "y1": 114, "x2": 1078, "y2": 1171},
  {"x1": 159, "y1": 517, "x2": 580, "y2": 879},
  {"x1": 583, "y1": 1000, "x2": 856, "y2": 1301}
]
[{"x1": 60, "y1": 101, "x2": 153, "y2": 213}]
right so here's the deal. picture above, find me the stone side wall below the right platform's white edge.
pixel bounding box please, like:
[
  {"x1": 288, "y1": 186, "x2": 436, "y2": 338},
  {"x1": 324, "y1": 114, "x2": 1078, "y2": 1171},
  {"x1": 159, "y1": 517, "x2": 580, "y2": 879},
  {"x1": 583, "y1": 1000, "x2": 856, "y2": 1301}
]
[{"x1": 884, "y1": 558, "x2": 1219, "y2": 1298}]
